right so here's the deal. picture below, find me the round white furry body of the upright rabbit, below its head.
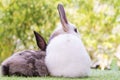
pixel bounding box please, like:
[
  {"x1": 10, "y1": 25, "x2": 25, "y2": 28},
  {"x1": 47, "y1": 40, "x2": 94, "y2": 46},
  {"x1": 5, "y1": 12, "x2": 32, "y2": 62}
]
[{"x1": 45, "y1": 34, "x2": 91, "y2": 77}]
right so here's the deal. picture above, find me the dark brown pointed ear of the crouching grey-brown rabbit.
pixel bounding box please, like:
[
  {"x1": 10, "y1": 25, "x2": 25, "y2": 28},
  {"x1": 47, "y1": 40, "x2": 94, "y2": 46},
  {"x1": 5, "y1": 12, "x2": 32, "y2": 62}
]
[{"x1": 34, "y1": 31, "x2": 47, "y2": 51}]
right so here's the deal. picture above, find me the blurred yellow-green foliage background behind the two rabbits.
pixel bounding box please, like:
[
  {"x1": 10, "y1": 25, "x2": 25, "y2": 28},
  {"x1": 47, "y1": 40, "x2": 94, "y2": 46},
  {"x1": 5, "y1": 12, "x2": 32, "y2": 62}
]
[{"x1": 0, "y1": 0, "x2": 120, "y2": 68}]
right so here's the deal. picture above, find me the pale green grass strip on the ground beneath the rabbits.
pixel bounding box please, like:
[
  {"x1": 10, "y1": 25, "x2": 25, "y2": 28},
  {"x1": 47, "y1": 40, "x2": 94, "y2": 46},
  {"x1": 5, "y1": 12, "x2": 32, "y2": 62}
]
[{"x1": 0, "y1": 69, "x2": 120, "y2": 80}]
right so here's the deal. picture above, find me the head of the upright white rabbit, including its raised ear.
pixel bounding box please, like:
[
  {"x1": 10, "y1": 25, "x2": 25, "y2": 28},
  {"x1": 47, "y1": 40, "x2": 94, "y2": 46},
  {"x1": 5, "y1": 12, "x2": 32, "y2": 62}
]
[{"x1": 50, "y1": 4, "x2": 79, "y2": 40}]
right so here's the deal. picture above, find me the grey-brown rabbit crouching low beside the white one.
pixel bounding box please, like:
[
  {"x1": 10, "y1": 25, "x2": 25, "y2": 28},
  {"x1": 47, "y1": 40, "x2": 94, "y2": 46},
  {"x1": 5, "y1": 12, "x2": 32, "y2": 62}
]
[{"x1": 1, "y1": 31, "x2": 49, "y2": 77}]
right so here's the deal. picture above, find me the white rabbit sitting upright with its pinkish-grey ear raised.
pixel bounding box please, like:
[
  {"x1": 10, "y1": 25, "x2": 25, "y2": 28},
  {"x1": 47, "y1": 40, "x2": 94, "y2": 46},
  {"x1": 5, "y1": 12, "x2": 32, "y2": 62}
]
[{"x1": 45, "y1": 4, "x2": 91, "y2": 78}]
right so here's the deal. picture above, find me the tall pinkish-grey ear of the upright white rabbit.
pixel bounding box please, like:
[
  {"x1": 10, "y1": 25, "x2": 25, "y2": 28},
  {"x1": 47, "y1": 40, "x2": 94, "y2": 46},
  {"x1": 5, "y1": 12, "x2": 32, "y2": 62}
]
[{"x1": 57, "y1": 4, "x2": 69, "y2": 32}]
